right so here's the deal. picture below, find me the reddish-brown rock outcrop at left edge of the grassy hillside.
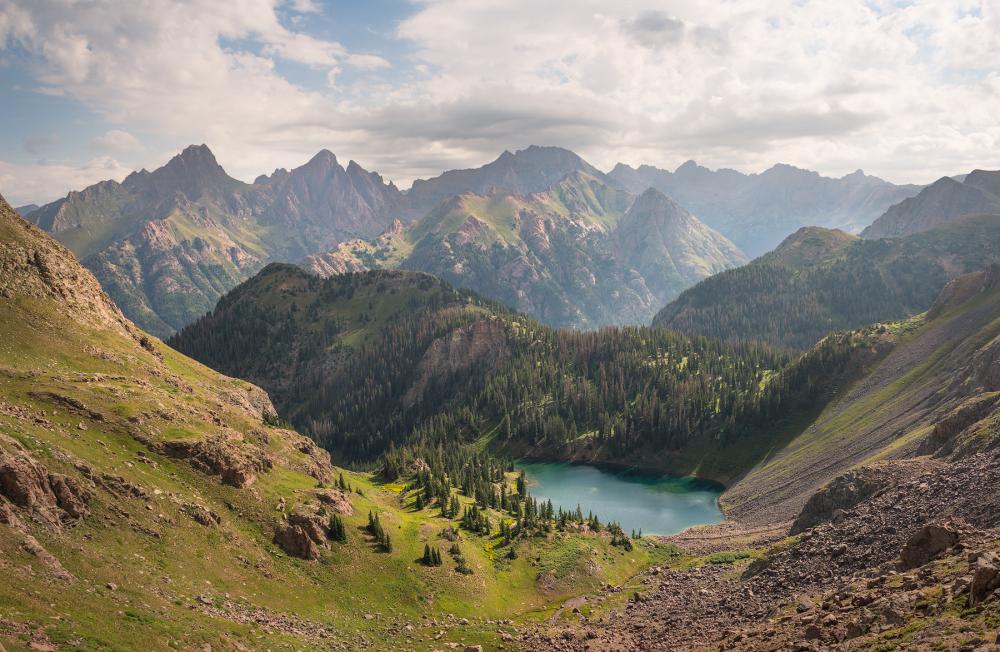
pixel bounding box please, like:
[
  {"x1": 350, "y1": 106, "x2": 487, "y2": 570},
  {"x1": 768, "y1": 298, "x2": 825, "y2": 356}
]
[{"x1": 0, "y1": 452, "x2": 91, "y2": 527}]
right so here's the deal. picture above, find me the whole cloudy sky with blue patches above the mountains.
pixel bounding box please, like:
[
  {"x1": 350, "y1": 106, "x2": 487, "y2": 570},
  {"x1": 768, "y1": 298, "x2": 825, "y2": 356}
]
[{"x1": 0, "y1": 0, "x2": 1000, "y2": 203}]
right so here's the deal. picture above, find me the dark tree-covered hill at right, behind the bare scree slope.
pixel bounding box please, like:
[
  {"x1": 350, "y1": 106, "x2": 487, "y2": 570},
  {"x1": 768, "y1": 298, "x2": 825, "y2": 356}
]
[{"x1": 653, "y1": 216, "x2": 1000, "y2": 349}]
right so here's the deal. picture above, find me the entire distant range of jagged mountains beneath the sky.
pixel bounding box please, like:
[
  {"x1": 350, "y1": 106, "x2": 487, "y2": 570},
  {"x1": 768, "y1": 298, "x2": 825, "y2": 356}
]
[{"x1": 22, "y1": 145, "x2": 932, "y2": 337}]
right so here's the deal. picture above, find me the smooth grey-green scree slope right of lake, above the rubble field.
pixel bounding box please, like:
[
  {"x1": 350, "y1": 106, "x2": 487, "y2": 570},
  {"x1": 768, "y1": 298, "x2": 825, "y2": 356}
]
[{"x1": 723, "y1": 266, "x2": 1000, "y2": 518}]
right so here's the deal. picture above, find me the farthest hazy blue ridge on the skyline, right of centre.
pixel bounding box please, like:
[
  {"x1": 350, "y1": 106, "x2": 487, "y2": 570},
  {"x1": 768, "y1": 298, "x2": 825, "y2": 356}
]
[{"x1": 608, "y1": 161, "x2": 920, "y2": 257}]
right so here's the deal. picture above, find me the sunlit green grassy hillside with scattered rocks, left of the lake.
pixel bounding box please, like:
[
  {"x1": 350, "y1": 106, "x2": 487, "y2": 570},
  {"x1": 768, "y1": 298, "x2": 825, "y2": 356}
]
[{"x1": 0, "y1": 194, "x2": 670, "y2": 650}]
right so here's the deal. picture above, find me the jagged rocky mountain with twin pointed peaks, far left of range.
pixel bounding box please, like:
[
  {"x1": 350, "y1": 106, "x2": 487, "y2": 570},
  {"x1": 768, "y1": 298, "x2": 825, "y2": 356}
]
[{"x1": 29, "y1": 145, "x2": 403, "y2": 337}]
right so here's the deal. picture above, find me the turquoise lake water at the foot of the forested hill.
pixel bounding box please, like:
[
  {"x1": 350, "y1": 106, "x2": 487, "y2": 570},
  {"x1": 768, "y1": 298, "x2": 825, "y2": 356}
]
[{"x1": 517, "y1": 463, "x2": 722, "y2": 534}]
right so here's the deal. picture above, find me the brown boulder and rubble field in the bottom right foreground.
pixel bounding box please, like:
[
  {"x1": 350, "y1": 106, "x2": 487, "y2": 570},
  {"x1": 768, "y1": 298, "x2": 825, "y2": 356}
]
[{"x1": 519, "y1": 451, "x2": 1000, "y2": 652}]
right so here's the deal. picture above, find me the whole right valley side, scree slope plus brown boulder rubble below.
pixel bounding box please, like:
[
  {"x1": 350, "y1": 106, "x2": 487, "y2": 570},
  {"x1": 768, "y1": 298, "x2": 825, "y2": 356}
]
[{"x1": 520, "y1": 267, "x2": 1000, "y2": 652}]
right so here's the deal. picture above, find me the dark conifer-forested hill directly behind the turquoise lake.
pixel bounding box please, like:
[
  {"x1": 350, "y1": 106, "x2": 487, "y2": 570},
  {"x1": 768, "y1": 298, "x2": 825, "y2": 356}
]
[{"x1": 170, "y1": 265, "x2": 888, "y2": 482}]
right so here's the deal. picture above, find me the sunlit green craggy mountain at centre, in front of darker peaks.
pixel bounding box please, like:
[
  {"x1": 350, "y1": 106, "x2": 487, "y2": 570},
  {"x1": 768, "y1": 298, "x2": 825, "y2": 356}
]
[{"x1": 304, "y1": 178, "x2": 746, "y2": 328}]
